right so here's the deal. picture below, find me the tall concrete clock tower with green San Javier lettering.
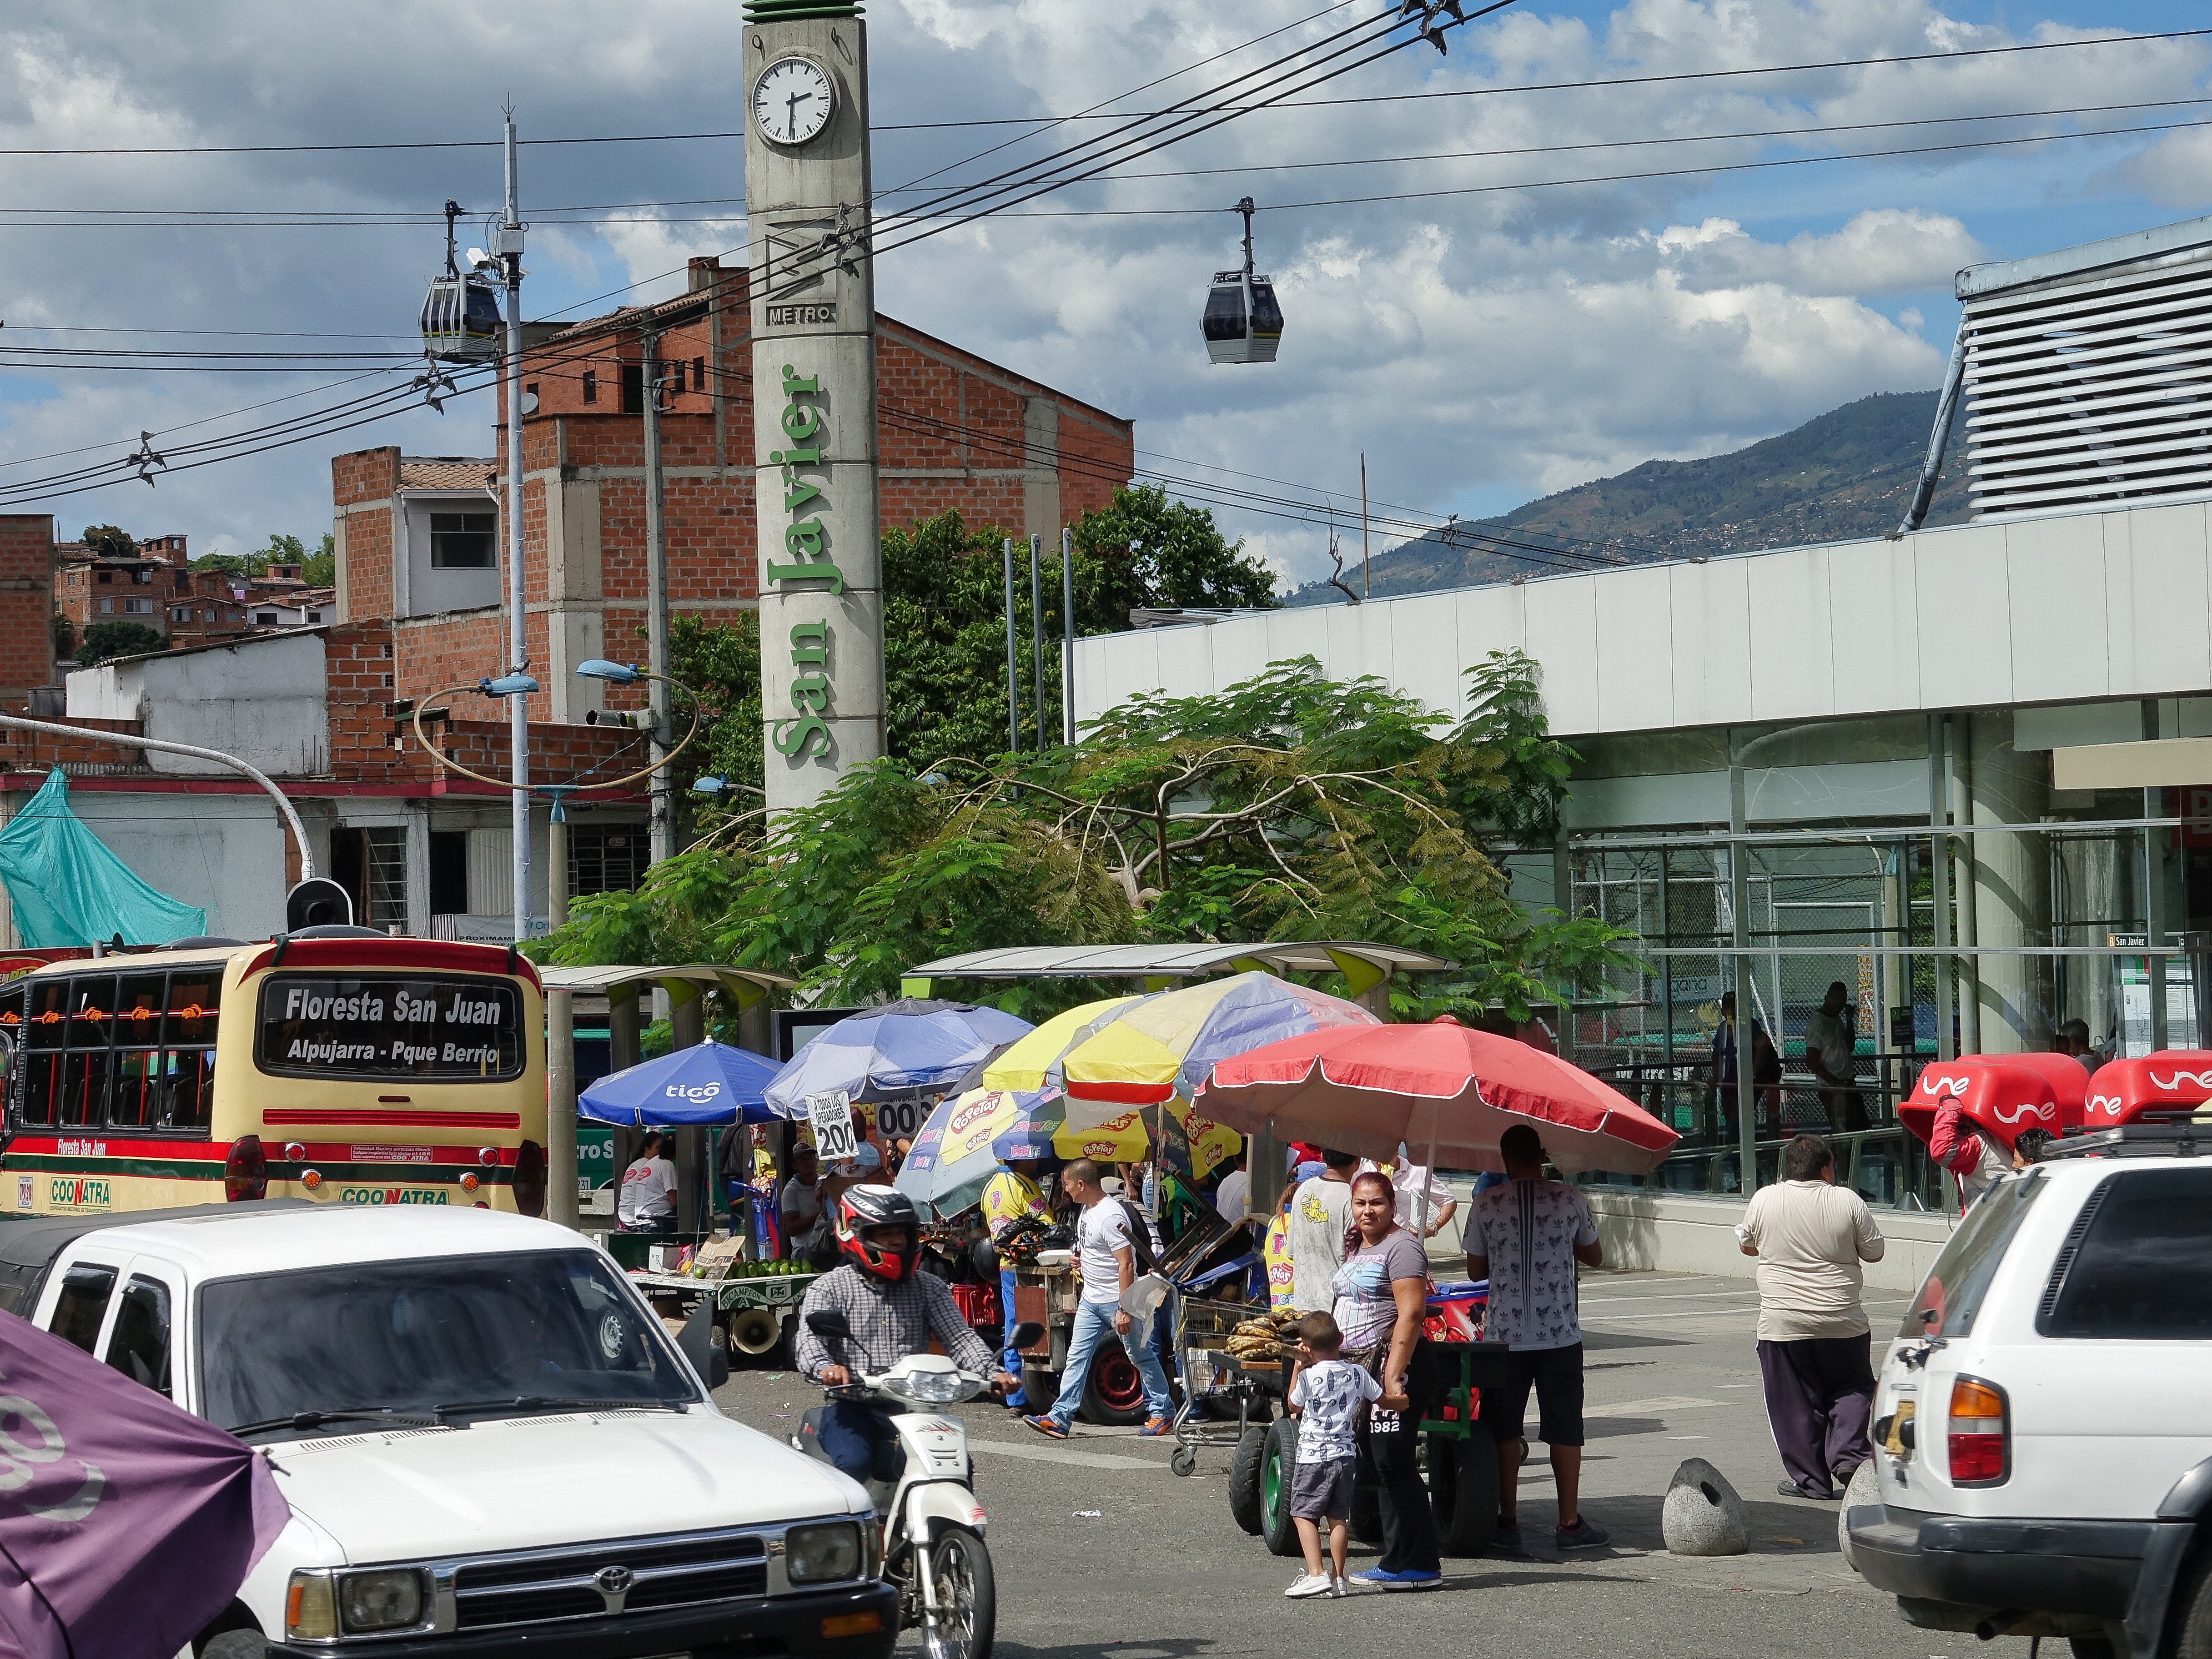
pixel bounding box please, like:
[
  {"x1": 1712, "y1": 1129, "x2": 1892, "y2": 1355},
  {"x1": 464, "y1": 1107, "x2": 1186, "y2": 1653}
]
[{"x1": 743, "y1": 0, "x2": 883, "y2": 814}]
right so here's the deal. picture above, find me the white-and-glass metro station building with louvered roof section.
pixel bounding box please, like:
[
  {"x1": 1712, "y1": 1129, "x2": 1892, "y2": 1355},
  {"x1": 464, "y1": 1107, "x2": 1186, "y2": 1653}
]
[{"x1": 1075, "y1": 219, "x2": 2212, "y2": 1201}]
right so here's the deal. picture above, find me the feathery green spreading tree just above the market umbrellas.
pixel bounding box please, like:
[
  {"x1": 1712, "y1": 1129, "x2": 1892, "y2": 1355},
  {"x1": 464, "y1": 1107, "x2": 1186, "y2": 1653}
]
[{"x1": 540, "y1": 659, "x2": 1633, "y2": 1017}]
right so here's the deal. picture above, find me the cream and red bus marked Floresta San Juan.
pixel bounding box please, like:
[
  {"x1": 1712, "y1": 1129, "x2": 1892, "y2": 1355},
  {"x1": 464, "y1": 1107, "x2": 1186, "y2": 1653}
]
[{"x1": 0, "y1": 927, "x2": 546, "y2": 1214}]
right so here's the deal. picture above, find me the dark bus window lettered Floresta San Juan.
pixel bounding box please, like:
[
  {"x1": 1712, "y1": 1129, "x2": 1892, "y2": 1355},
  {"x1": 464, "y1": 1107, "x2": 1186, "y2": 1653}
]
[{"x1": 254, "y1": 973, "x2": 522, "y2": 1081}]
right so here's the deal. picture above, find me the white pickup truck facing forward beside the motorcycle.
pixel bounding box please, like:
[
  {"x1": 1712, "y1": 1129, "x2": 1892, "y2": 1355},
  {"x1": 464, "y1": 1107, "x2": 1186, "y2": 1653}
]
[{"x1": 0, "y1": 1203, "x2": 898, "y2": 1659}]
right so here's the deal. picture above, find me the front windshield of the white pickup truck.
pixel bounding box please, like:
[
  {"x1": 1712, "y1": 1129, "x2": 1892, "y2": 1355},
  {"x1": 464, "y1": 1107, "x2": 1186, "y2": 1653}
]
[{"x1": 199, "y1": 1250, "x2": 699, "y2": 1433}]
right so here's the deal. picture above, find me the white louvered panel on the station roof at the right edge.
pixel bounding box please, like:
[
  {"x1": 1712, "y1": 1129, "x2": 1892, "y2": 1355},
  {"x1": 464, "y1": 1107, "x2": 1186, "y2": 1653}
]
[{"x1": 1964, "y1": 250, "x2": 2212, "y2": 520}]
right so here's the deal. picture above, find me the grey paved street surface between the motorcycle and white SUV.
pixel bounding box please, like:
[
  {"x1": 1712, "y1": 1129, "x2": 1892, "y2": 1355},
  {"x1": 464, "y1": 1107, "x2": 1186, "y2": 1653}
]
[{"x1": 721, "y1": 1274, "x2": 2026, "y2": 1659}]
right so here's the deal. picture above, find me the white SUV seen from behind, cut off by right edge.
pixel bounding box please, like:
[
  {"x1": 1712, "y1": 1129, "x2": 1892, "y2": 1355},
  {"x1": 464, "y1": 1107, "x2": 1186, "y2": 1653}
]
[{"x1": 1845, "y1": 1124, "x2": 2212, "y2": 1659}]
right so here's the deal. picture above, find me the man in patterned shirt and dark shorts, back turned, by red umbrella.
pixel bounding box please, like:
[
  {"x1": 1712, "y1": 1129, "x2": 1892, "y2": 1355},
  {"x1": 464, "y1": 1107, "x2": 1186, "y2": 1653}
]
[{"x1": 1462, "y1": 1124, "x2": 1610, "y2": 1551}]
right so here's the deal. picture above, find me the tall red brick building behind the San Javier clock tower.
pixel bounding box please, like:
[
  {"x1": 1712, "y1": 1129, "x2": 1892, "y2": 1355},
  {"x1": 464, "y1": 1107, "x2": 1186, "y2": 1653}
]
[{"x1": 345, "y1": 259, "x2": 1135, "y2": 721}]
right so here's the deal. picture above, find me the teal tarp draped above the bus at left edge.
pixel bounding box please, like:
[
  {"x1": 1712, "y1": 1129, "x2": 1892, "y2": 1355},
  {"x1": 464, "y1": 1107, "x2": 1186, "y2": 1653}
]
[{"x1": 0, "y1": 768, "x2": 208, "y2": 949}]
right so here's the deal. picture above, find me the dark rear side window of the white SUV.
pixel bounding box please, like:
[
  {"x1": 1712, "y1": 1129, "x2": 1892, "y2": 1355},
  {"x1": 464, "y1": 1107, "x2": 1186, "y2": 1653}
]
[{"x1": 2035, "y1": 1170, "x2": 2212, "y2": 1341}]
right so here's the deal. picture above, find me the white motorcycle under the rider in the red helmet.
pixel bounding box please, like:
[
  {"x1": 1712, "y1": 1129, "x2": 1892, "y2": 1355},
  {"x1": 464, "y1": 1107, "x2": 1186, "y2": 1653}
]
[{"x1": 792, "y1": 1312, "x2": 1044, "y2": 1659}]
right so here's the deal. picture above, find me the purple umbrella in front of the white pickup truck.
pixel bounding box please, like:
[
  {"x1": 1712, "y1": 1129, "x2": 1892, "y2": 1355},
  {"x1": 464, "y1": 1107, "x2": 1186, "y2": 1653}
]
[{"x1": 0, "y1": 1314, "x2": 292, "y2": 1659}]
